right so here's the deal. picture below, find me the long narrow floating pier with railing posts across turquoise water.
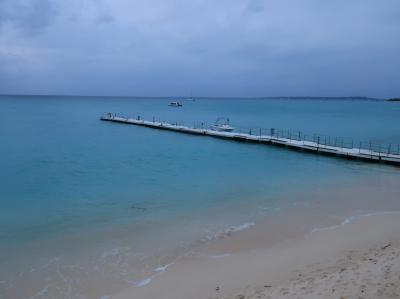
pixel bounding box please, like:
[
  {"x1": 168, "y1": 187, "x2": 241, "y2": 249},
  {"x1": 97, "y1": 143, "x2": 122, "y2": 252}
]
[{"x1": 100, "y1": 113, "x2": 400, "y2": 166}]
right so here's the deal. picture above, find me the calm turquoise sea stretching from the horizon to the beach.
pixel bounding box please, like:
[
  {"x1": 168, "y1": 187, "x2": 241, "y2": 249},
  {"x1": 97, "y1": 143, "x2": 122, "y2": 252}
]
[{"x1": 0, "y1": 96, "x2": 400, "y2": 298}]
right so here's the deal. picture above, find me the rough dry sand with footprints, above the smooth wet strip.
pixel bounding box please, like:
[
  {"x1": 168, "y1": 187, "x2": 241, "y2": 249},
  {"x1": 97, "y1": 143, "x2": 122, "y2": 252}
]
[{"x1": 209, "y1": 243, "x2": 400, "y2": 299}]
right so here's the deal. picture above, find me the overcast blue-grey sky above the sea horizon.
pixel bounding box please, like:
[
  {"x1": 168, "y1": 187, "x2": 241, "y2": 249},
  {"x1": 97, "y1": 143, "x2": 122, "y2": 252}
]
[{"x1": 0, "y1": 0, "x2": 400, "y2": 97}]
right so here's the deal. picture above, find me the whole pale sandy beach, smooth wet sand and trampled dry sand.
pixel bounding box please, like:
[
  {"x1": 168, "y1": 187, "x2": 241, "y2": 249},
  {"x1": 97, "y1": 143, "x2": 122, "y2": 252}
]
[{"x1": 112, "y1": 212, "x2": 400, "y2": 299}]
